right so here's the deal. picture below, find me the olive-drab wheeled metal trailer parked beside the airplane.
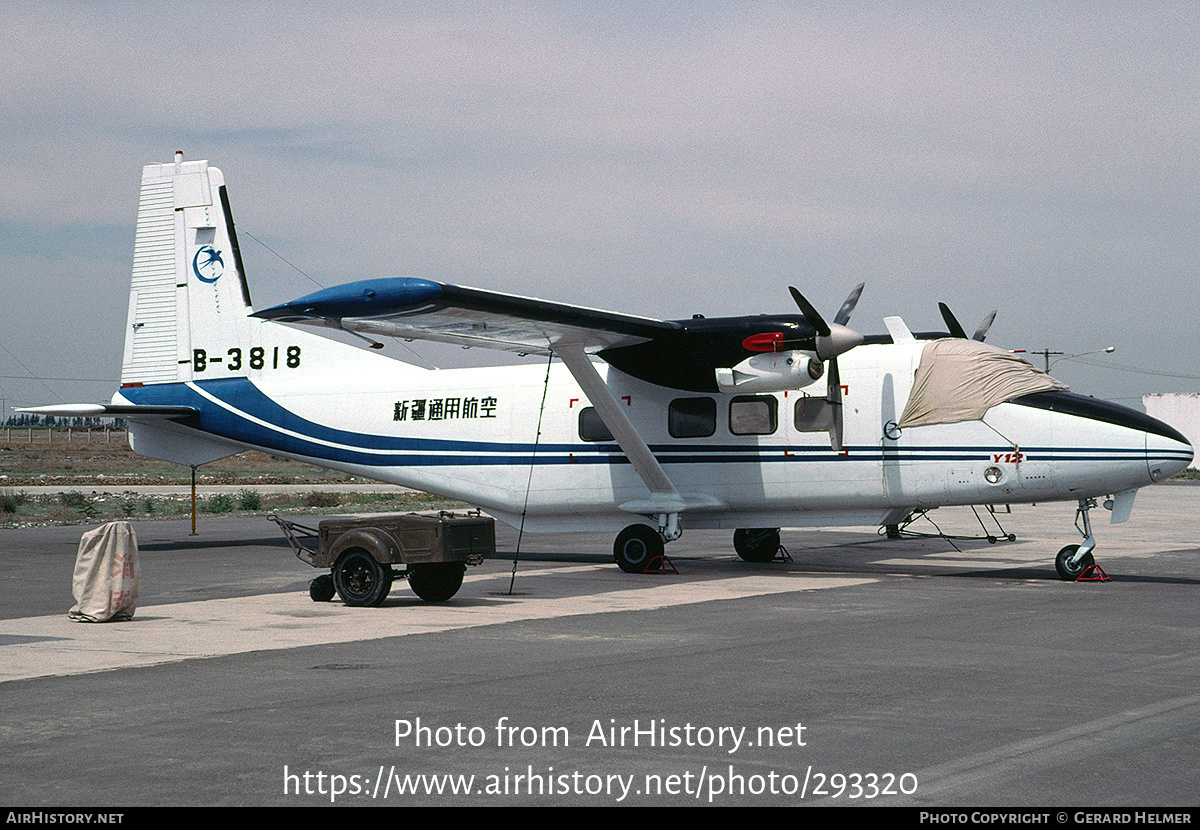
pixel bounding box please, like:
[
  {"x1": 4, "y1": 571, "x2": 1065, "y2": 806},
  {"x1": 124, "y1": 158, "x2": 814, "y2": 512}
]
[{"x1": 270, "y1": 511, "x2": 496, "y2": 606}]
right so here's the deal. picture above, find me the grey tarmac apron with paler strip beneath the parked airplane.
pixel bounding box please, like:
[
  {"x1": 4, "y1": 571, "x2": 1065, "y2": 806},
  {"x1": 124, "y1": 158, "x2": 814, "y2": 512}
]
[{"x1": 0, "y1": 485, "x2": 1200, "y2": 816}]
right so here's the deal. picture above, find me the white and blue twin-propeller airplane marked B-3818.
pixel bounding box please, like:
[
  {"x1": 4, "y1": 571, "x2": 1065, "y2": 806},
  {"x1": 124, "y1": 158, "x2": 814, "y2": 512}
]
[{"x1": 18, "y1": 152, "x2": 1193, "y2": 581}]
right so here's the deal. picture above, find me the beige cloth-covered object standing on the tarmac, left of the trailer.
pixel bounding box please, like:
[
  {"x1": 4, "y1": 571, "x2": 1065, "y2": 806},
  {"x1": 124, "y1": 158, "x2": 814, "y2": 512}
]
[{"x1": 67, "y1": 522, "x2": 139, "y2": 623}]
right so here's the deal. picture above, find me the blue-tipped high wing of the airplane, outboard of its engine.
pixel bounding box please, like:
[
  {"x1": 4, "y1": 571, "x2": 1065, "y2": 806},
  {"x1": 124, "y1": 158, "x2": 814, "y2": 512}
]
[{"x1": 253, "y1": 277, "x2": 682, "y2": 355}]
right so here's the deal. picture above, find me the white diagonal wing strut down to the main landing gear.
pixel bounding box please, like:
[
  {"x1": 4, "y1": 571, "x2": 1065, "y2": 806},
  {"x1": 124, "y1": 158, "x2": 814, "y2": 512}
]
[{"x1": 552, "y1": 343, "x2": 686, "y2": 540}]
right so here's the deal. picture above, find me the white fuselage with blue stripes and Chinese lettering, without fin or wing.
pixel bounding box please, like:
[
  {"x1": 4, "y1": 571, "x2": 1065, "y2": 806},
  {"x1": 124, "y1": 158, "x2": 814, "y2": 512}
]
[{"x1": 121, "y1": 326, "x2": 1186, "y2": 530}]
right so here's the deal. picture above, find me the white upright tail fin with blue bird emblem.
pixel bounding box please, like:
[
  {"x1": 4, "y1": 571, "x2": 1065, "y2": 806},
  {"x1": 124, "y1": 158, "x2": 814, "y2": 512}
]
[{"x1": 121, "y1": 154, "x2": 251, "y2": 385}]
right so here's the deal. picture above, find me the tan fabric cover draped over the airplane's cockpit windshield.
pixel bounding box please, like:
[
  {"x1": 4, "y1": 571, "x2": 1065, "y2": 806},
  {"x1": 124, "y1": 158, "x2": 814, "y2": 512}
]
[{"x1": 899, "y1": 337, "x2": 1067, "y2": 428}]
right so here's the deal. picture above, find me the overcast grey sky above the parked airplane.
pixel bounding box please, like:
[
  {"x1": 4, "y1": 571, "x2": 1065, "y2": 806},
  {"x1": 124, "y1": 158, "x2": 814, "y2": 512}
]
[{"x1": 0, "y1": 0, "x2": 1200, "y2": 422}]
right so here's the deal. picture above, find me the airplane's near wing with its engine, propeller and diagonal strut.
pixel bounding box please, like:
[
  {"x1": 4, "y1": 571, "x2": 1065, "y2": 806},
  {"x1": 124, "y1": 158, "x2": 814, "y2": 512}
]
[{"x1": 253, "y1": 277, "x2": 864, "y2": 467}]
